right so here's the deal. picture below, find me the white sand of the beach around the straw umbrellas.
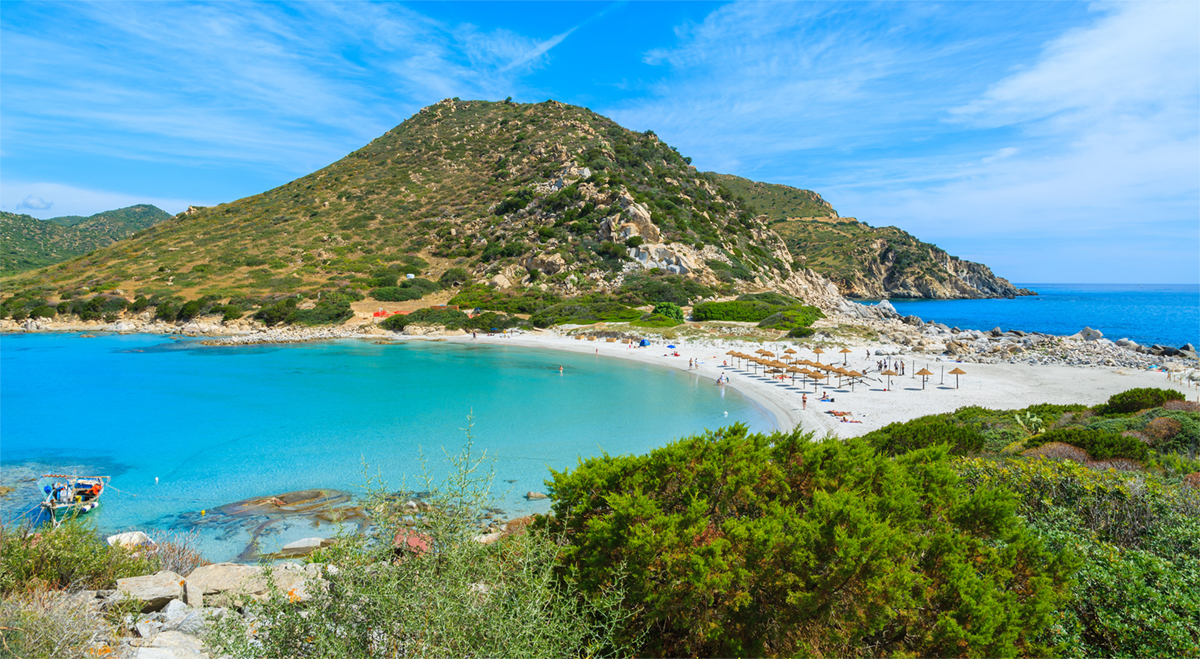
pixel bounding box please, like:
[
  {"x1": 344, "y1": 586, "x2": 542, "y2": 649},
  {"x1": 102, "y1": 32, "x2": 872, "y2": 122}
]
[{"x1": 439, "y1": 331, "x2": 1200, "y2": 437}]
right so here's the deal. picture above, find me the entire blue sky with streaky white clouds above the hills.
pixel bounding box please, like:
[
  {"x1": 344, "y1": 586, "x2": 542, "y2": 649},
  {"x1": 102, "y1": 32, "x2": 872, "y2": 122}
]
[{"x1": 0, "y1": 1, "x2": 1200, "y2": 283}]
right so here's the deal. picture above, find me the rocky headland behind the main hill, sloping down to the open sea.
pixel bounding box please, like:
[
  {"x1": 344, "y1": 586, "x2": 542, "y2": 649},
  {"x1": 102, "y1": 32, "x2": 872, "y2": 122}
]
[{"x1": 713, "y1": 174, "x2": 1036, "y2": 299}]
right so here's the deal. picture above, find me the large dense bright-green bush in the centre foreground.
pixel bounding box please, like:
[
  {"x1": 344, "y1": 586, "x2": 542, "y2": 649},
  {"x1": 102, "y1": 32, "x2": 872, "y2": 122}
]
[{"x1": 542, "y1": 425, "x2": 1067, "y2": 657}]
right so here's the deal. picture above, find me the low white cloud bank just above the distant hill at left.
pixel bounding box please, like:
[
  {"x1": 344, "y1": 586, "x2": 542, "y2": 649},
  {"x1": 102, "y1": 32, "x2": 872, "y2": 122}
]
[{"x1": 0, "y1": 178, "x2": 202, "y2": 220}]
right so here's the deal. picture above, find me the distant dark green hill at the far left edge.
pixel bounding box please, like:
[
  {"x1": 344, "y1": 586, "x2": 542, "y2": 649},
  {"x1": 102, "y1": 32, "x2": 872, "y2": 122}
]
[{"x1": 0, "y1": 204, "x2": 170, "y2": 275}]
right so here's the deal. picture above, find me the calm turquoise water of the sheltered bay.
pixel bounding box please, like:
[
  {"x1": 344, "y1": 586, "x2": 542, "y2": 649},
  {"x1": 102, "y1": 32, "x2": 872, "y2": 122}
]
[{"x1": 0, "y1": 334, "x2": 774, "y2": 561}]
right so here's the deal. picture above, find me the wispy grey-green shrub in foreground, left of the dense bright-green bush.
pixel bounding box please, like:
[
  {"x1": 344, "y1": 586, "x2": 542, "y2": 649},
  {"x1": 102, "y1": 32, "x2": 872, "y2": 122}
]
[{"x1": 209, "y1": 438, "x2": 638, "y2": 658}]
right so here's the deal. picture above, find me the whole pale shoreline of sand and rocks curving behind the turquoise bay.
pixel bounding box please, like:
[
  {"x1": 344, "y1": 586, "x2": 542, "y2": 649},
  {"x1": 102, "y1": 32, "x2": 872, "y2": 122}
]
[{"x1": 11, "y1": 317, "x2": 1200, "y2": 437}]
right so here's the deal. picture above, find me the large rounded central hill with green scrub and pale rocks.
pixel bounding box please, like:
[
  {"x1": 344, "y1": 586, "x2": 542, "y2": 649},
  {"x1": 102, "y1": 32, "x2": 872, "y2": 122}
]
[{"x1": 6, "y1": 100, "x2": 838, "y2": 304}]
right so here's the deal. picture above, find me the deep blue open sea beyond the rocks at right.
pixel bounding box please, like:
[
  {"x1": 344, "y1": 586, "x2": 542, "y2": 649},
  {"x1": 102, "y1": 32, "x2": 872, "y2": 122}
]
[{"x1": 890, "y1": 283, "x2": 1200, "y2": 348}]
